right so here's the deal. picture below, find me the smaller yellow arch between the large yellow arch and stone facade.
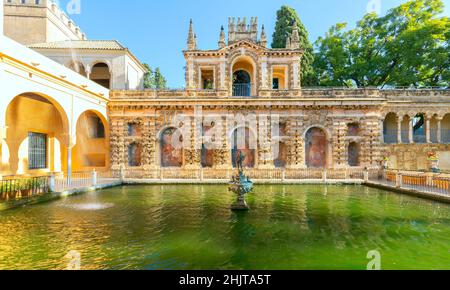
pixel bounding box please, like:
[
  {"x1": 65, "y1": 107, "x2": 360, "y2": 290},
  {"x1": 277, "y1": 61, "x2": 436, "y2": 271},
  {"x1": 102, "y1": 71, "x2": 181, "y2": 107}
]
[{"x1": 72, "y1": 110, "x2": 109, "y2": 171}]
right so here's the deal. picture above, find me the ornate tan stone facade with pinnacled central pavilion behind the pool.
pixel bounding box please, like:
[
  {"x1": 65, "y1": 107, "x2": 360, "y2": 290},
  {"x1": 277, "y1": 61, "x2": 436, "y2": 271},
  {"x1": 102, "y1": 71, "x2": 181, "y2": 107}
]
[{"x1": 109, "y1": 18, "x2": 450, "y2": 175}]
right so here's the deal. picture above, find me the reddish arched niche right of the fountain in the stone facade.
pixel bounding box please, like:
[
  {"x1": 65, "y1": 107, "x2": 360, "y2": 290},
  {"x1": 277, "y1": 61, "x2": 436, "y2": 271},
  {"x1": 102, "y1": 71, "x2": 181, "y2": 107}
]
[{"x1": 304, "y1": 127, "x2": 328, "y2": 168}]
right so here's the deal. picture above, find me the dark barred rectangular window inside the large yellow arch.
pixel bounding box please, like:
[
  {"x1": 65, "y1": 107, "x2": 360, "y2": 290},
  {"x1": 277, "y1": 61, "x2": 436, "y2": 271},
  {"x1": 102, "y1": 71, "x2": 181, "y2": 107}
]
[{"x1": 28, "y1": 132, "x2": 47, "y2": 170}]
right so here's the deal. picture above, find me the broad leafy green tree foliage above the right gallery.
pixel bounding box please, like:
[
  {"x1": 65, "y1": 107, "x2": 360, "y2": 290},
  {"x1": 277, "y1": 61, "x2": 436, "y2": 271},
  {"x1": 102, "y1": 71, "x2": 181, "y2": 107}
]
[{"x1": 314, "y1": 0, "x2": 450, "y2": 87}]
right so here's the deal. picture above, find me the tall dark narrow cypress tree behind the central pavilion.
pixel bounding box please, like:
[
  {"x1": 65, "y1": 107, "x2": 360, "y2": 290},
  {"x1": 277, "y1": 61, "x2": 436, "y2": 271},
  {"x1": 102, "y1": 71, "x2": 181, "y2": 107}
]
[{"x1": 272, "y1": 5, "x2": 315, "y2": 85}]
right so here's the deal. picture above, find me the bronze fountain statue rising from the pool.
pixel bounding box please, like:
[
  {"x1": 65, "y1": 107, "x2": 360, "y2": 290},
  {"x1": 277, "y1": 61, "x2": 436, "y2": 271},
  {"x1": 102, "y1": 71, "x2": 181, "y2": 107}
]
[{"x1": 228, "y1": 151, "x2": 253, "y2": 211}]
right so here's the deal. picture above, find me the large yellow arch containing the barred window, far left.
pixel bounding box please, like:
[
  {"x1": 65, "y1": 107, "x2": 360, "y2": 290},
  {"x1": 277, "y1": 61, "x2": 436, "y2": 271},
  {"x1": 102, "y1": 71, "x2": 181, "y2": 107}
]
[{"x1": 2, "y1": 92, "x2": 70, "y2": 174}]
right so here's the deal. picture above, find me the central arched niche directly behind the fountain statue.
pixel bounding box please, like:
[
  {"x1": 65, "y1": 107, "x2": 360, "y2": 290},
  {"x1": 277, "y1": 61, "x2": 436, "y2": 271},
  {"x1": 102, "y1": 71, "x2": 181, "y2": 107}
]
[{"x1": 231, "y1": 126, "x2": 257, "y2": 168}]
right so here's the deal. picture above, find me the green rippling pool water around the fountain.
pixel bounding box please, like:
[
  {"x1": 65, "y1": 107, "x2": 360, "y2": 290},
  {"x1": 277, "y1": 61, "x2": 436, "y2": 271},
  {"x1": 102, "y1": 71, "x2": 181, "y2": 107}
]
[{"x1": 0, "y1": 185, "x2": 450, "y2": 270}]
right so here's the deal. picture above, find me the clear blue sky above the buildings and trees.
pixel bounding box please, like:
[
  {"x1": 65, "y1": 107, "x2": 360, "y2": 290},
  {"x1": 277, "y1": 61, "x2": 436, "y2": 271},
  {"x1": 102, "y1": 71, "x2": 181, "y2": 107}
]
[{"x1": 60, "y1": 0, "x2": 450, "y2": 87}]
